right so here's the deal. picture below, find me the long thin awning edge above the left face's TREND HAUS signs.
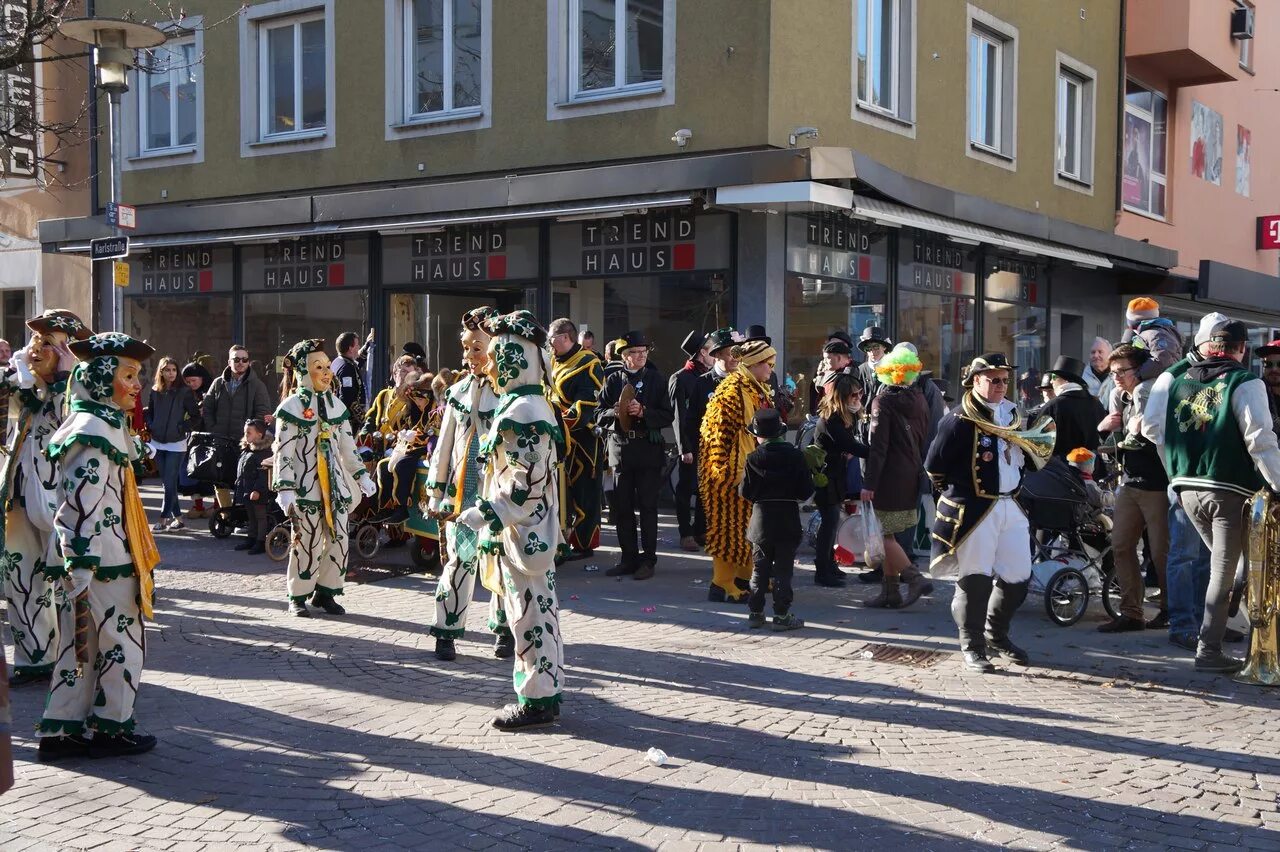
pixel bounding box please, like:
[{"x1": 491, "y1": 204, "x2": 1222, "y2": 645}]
[{"x1": 49, "y1": 192, "x2": 700, "y2": 253}]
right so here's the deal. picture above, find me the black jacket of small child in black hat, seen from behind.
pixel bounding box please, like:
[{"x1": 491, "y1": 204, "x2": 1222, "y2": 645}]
[{"x1": 737, "y1": 441, "x2": 813, "y2": 545}]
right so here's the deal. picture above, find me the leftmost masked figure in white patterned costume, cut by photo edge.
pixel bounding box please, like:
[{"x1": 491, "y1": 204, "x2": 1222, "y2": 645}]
[{"x1": 0, "y1": 310, "x2": 90, "y2": 686}]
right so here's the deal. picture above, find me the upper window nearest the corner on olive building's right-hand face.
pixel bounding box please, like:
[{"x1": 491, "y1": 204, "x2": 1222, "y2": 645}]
[{"x1": 854, "y1": 0, "x2": 915, "y2": 122}]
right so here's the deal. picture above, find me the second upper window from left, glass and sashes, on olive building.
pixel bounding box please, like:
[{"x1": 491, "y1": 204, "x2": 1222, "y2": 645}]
[{"x1": 257, "y1": 14, "x2": 328, "y2": 139}]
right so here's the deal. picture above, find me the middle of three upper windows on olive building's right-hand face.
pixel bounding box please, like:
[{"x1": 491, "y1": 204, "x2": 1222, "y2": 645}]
[{"x1": 968, "y1": 6, "x2": 1018, "y2": 168}]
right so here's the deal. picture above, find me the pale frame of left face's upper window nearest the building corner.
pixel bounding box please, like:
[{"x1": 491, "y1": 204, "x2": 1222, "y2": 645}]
[{"x1": 547, "y1": 0, "x2": 677, "y2": 120}]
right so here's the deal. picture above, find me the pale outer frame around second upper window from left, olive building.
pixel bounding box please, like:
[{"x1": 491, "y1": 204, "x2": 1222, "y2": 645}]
[{"x1": 238, "y1": 0, "x2": 338, "y2": 157}]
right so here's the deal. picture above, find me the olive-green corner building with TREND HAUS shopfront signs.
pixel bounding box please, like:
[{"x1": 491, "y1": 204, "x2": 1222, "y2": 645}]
[{"x1": 41, "y1": 0, "x2": 1176, "y2": 411}]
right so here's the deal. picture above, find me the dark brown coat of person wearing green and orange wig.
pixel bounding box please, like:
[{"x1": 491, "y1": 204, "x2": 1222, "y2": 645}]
[{"x1": 863, "y1": 384, "x2": 929, "y2": 512}]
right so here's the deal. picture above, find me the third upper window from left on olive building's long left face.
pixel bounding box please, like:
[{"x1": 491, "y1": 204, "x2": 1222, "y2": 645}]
[{"x1": 403, "y1": 0, "x2": 483, "y2": 120}]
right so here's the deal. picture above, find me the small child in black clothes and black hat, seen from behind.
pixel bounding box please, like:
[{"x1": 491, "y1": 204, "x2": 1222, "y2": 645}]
[{"x1": 739, "y1": 408, "x2": 813, "y2": 631}]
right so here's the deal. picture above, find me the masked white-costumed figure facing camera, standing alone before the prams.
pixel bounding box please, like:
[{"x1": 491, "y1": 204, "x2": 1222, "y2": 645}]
[{"x1": 271, "y1": 340, "x2": 376, "y2": 617}]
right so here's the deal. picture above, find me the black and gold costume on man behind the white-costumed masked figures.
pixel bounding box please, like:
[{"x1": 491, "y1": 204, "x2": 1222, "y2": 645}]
[{"x1": 550, "y1": 345, "x2": 604, "y2": 555}]
